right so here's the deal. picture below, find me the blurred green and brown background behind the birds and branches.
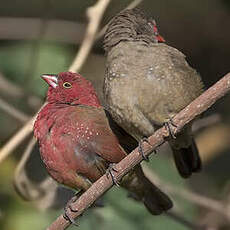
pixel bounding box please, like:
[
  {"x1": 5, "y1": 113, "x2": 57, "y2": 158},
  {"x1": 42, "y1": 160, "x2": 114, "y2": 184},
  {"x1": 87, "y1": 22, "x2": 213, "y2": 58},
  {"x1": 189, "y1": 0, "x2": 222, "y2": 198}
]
[{"x1": 0, "y1": 0, "x2": 230, "y2": 230}]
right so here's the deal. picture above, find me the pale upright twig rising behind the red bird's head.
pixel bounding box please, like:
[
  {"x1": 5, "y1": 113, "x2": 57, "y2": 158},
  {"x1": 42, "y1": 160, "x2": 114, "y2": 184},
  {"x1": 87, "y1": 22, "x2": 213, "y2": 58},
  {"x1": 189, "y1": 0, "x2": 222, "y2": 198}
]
[{"x1": 69, "y1": 0, "x2": 110, "y2": 72}]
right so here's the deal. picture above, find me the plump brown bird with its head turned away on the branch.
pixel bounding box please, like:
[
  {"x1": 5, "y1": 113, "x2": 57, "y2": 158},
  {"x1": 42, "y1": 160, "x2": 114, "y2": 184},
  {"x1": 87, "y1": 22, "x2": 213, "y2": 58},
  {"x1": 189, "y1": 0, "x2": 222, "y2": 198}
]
[{"x1": 104, "y1": 8, "x2": 203, "y2": 178}]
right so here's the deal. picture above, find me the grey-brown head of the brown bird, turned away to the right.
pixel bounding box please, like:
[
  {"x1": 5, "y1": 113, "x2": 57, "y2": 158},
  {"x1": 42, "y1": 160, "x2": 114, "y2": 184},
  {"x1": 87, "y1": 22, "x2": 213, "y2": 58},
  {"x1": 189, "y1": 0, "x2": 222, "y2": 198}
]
[{"x1": 104, "y1": 8, "x2": 165, "y2": 51}]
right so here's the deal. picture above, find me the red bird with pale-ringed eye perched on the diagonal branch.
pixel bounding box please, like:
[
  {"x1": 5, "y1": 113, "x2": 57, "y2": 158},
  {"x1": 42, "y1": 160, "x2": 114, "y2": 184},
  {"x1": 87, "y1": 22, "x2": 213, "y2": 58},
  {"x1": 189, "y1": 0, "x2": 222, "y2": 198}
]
[{"x1": 34, "y1": 72, "x2": 172, "y2": 219}]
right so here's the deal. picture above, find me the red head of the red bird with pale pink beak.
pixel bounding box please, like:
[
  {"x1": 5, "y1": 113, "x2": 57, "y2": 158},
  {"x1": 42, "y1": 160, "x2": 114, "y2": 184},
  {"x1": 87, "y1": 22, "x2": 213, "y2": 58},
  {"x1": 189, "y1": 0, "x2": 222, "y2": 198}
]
[{"x1": 41, "y1": 72, "x2": 101, "y2": 107}]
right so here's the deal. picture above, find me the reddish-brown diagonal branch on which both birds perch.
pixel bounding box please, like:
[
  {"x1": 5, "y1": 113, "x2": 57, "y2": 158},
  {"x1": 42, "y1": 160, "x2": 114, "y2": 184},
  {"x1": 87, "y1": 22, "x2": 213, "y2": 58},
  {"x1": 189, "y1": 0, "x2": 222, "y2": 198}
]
[{"x1": 47, "y1": 73, "x2": 230, "y2": 230}]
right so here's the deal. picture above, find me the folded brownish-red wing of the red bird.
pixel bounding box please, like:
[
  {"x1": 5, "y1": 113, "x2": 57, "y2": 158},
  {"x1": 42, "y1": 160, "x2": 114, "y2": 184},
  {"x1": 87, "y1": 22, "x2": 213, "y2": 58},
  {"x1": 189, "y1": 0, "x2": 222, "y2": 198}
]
[{"x1": 70, "y1": 105, "x2": 126, "y2": 163}]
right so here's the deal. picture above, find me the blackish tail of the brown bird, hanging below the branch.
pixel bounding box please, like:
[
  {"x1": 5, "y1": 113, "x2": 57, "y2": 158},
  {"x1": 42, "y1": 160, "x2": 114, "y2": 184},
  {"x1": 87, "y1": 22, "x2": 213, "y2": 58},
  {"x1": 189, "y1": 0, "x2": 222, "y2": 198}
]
[{"x1": 172, "y1": 139, "x2": 202, "y2": 178}]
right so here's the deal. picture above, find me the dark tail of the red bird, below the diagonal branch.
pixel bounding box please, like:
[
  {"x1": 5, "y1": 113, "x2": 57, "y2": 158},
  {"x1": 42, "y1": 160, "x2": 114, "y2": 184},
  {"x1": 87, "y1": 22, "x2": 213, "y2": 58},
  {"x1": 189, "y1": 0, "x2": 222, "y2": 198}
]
[{"x1": 121, "y1": 165, "x2": 173, "y2": 215}]
